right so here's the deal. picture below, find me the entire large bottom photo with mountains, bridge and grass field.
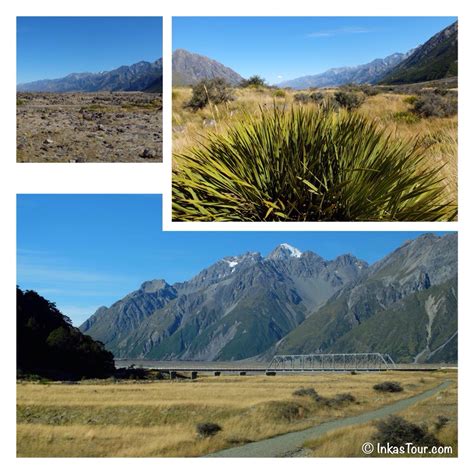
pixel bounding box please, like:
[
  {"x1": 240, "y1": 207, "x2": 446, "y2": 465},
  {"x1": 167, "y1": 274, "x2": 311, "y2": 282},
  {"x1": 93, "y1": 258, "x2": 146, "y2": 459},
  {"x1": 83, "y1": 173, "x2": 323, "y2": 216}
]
[{"x1": 16, "y1": 194, "x2": 458, "y2": 457}]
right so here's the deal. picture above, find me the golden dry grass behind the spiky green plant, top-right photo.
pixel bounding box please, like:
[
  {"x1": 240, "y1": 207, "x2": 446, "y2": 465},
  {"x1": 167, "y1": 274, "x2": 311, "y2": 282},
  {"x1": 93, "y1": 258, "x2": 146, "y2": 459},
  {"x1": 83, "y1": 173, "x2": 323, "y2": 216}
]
[{"x1": 173, "y1": 87, "x2": 457, "y2": 206}]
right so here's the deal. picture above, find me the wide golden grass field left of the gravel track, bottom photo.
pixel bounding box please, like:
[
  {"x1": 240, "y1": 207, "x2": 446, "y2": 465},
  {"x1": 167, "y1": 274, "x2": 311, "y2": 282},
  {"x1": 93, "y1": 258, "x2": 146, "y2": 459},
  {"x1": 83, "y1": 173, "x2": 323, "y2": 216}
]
[{"x1": 17, "y1": 372, "x2": 454, "y2": 457}]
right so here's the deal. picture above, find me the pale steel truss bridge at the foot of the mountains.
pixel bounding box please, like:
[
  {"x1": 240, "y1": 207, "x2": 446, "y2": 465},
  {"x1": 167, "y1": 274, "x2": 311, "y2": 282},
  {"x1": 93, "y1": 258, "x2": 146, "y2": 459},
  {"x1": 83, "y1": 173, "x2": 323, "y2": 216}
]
[{"x1": 266, "y1": 352, "x2": 397, "y2": 372}]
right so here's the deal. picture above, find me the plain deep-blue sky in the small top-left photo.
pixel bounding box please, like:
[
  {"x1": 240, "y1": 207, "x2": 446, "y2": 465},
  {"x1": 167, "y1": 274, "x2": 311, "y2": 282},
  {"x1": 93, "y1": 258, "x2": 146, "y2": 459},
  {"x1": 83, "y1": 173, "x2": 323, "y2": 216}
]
[{"x1": 17, "y1": 17, "x2": 162, "y2": 83}]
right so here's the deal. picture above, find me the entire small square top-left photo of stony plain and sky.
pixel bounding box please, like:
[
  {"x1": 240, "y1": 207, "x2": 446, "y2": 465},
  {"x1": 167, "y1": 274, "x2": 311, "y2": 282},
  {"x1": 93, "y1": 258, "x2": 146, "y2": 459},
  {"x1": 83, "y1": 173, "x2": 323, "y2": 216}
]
[{"x1": 16, "y1": 17, "x2": 163, "y2": 163}]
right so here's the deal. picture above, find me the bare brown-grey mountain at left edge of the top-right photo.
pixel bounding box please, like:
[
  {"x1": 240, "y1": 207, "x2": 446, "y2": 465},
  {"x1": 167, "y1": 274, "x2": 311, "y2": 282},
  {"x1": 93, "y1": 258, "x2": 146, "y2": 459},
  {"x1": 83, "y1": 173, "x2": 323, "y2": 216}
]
[{"x1": 173, "y1": 49, "x2": 243, "y2": 86}]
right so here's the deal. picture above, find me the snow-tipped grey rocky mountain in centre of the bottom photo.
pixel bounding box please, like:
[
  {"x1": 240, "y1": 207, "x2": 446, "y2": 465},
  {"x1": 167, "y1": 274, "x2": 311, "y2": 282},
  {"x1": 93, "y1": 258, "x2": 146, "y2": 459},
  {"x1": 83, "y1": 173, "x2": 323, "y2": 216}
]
[{"x1": 81, "y1": 244, "x2": 367, "y2": 360}]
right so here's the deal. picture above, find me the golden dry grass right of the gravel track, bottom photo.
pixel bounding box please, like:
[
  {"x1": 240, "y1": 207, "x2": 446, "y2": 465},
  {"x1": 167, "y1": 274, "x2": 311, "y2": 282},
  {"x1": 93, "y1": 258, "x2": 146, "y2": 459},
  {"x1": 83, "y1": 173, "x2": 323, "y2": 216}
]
[{"x1": 305, "y1": 377, "x2": 458, "y2": 457}]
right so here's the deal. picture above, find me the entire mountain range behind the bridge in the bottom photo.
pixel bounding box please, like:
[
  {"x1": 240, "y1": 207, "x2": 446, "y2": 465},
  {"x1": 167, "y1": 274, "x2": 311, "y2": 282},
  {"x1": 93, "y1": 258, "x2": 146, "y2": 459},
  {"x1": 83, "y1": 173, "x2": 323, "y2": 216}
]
[{"x1": 80, "y1": 234, "x2": 457, "y2": 362}]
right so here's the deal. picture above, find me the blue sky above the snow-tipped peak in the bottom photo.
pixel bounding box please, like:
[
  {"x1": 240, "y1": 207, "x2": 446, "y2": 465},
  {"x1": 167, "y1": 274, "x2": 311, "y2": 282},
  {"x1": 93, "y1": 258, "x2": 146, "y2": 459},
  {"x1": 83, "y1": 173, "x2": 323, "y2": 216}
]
[{"x1": 17, "y1": 194, "x2": 452, "y2": 324}]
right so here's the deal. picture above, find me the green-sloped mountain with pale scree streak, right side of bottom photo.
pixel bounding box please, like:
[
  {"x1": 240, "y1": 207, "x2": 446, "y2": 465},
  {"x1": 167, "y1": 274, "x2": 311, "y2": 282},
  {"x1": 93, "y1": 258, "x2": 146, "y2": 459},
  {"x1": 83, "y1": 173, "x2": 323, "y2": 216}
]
[{"x1": 275, "y1": 234, "x2": 457, "y2": 362}]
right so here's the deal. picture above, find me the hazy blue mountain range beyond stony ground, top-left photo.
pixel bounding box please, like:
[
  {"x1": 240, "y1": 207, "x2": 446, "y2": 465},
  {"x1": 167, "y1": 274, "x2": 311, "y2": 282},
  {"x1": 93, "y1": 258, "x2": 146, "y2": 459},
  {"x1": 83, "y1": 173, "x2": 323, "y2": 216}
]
[{"x1": 17, "y1": 59, "x2": 163, "y2": 92}]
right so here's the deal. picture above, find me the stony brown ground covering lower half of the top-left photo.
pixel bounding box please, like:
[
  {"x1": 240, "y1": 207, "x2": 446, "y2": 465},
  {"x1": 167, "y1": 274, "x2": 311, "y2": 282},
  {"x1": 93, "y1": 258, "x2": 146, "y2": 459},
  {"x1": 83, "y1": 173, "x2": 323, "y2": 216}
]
[{"x1": 17, "y1": 92, "x2": 162, "y2": 163}]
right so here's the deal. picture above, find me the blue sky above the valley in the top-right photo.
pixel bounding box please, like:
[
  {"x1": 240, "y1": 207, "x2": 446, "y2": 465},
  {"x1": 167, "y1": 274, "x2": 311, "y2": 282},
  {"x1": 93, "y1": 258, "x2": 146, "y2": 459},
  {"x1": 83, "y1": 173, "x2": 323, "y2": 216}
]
[{"x1": 173, "y1": 17, "x2": 456, "y2": 83}]
